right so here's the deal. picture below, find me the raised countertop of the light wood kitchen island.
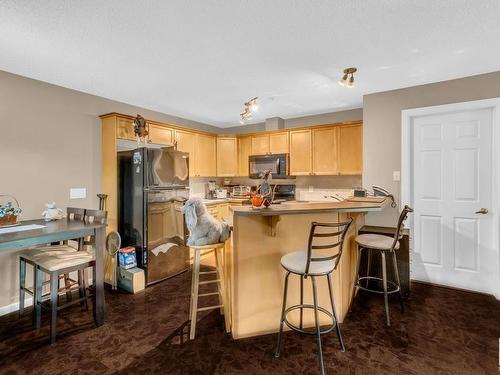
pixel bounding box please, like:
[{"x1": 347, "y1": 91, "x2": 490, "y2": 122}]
[{"x1": 232, "y1": 198, "x2": 390, "y2": 216}]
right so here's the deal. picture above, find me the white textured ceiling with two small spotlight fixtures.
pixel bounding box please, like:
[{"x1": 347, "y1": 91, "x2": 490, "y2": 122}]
[{"x1": 0, "y1": 0, "x2": 500, "y2": 127}]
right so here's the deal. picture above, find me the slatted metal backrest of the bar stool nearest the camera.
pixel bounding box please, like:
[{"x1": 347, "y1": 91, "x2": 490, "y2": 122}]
[{"x1": 305, "y1": 218, "x2": 352, "y2": 276}]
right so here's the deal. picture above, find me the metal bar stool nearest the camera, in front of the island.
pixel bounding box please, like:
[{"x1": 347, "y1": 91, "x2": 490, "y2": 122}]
[{"x1": 275, "y1": 218, "x2": 352, "y2": 374}]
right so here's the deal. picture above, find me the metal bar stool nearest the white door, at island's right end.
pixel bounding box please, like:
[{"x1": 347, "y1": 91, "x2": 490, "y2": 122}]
[{"x1": 351, "y1": 206, "x2": 413, "y2": 327}]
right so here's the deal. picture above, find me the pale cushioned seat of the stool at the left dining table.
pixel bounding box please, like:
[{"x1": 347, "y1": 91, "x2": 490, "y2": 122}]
[{"x1": 21, "y1": 250, "x2": 94, "y2": 272}]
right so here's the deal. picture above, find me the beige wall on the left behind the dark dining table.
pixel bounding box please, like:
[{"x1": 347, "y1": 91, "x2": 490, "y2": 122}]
[{"x1": 0, "y1": 71, "x2": 218, "y2": 308}]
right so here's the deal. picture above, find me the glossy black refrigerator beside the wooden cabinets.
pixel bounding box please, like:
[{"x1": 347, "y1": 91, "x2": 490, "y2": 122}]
[{"x1": 118, "y1": 147, "x2": 189, "y2": 285}]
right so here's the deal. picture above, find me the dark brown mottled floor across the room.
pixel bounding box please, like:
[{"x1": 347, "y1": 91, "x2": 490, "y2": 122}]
[{"x1": 0, "y1": 273, "x2": 500, "y2": 374}]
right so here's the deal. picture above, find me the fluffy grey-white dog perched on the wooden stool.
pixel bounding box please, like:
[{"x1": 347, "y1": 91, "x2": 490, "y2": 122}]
[{"x1": 182, "y1": 198, "x2": 230, "y2": 246}]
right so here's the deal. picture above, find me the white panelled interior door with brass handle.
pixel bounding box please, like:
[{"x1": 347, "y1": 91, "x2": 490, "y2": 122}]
[{"x1": 412, "y1": 109, "x2": 498, "y2": 293}]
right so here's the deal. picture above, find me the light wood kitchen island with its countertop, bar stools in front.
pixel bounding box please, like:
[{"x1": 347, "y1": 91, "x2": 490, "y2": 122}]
[{"x1": 226, "y1": 199, "x2": 388, "y2": 339}]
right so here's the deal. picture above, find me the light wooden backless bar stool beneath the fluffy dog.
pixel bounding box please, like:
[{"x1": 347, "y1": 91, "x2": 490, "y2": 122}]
[{"x1": 189, "y1": 242, "x2": 230, "y2": 340}]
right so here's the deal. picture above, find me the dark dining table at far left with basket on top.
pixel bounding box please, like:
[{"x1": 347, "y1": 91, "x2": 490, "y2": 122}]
[{"x1": 0, "y1": 219, "x2": 106, "y2": 326}]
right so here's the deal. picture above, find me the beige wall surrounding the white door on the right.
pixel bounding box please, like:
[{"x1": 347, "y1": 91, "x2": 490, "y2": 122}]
[{"x1": 363, "y1": 72, "x2": 500, "y2": 226}]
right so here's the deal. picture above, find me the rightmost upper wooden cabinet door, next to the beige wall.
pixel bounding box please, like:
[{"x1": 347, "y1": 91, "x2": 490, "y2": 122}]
[{"x1": 338, "y1": 125, "x2": 363, "y2": 175}]
